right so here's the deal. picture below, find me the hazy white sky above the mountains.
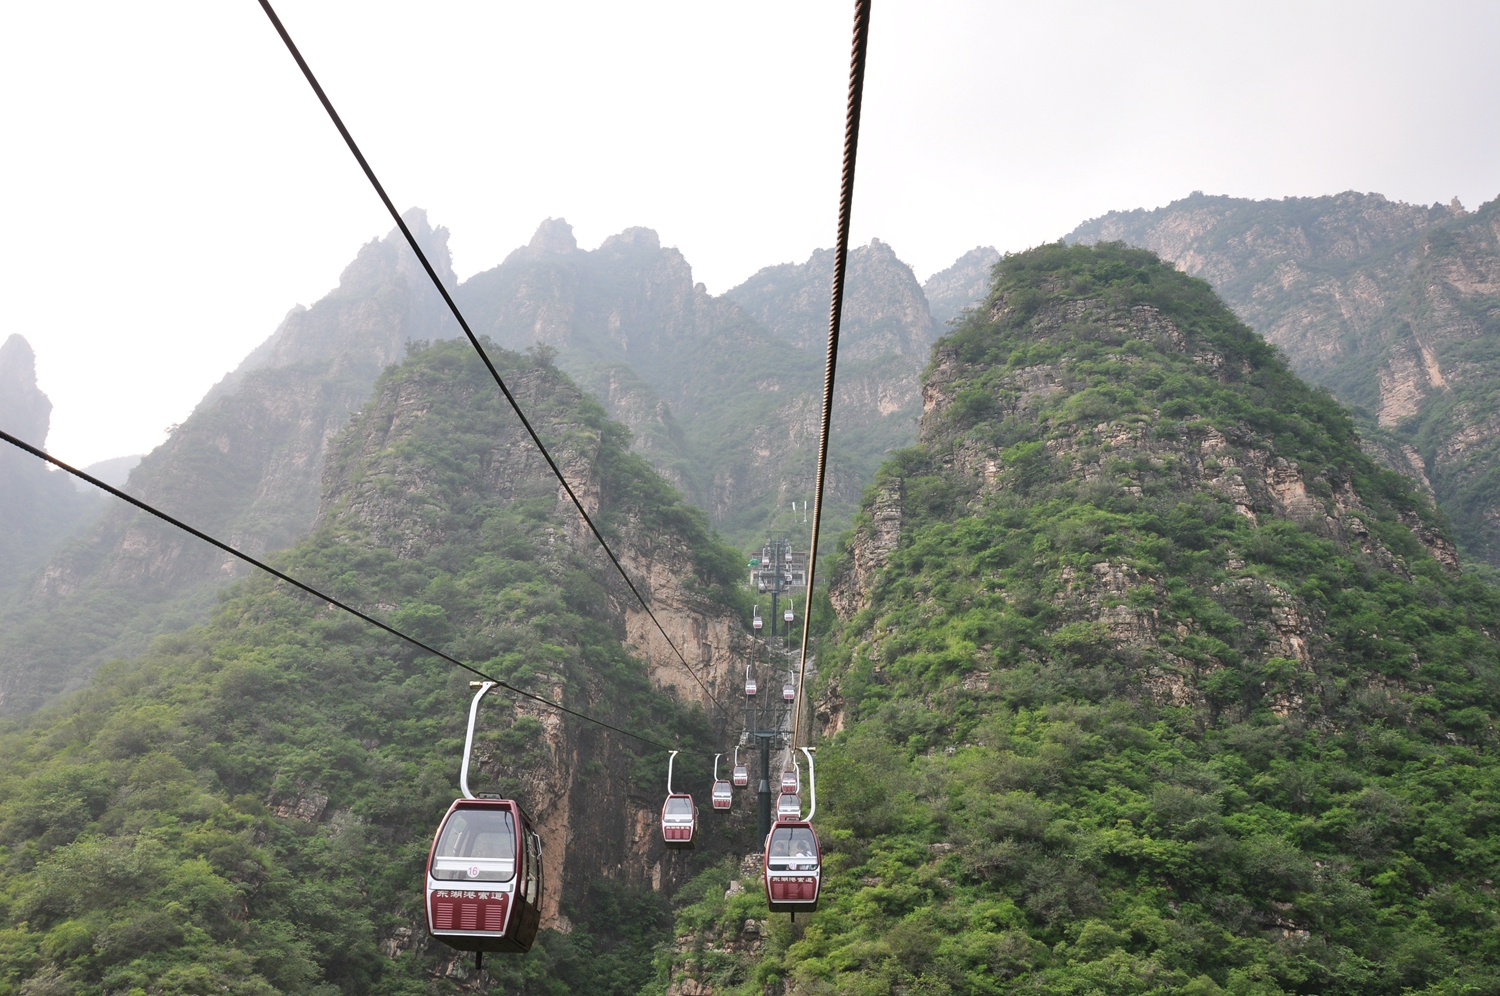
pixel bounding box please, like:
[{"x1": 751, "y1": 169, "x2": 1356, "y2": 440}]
[{"x1": 0, "y1": 0, "x2": 1500, "y2": 462}]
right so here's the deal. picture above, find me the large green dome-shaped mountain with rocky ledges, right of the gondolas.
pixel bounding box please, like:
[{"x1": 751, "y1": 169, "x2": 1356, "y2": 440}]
[{"x1": 669, "y1": 245, "x2": 1500, "y2": 996}]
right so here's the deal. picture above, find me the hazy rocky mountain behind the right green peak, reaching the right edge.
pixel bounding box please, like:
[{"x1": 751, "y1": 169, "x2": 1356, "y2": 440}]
[{"x1": 1070, "y1": 194, "x2": 1500, "y2": 563}]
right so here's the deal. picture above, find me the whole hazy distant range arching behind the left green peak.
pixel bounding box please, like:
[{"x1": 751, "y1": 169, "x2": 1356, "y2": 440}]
[{"x1": 0, "y1": 210, "x2": 984, "y2": 714}]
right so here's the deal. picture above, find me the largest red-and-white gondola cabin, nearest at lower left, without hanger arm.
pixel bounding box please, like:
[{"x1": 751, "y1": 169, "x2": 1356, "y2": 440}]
[{"x1": 428, "y1": 800, "x2": 542, "y2": 951}]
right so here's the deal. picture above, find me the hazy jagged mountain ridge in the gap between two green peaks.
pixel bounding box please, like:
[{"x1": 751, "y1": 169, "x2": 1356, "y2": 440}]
[{"x1": 459, "y1": 219, "x2": 932, "y2": 545}]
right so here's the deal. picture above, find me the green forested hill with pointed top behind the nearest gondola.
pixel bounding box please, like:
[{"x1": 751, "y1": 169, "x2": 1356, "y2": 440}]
[{"x1": 0, "y1": 342, "x2": 738, "y2": 996}]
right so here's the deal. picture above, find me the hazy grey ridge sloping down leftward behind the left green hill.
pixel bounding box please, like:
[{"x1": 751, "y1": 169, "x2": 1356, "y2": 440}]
[{"x1": 0, "y1": 212, "x2": 452, "y2": 713}]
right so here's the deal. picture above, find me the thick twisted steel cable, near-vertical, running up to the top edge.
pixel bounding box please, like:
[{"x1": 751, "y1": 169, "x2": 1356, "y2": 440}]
[{"x1": 791, "y1": 0, "x2": 870, "y2": 750}]
